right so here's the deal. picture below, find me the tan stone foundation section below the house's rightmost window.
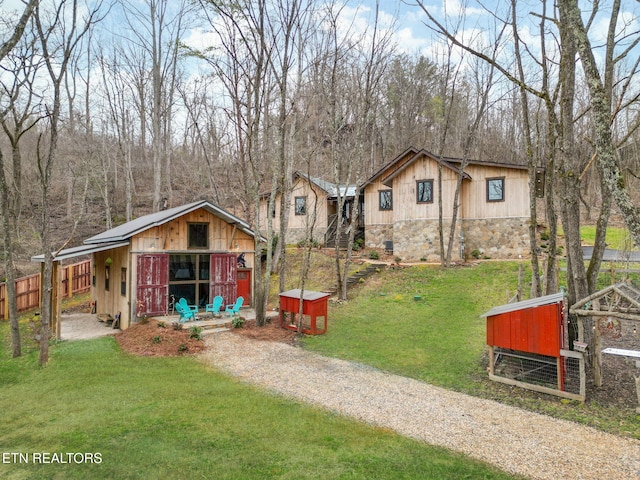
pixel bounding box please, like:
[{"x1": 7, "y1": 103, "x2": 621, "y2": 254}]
[{"x1": 463, "y1": 217, "x2": 529, "y2": 258}]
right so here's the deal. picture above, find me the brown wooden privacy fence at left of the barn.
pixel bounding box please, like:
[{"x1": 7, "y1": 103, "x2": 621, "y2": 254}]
[{"x1": 0, "y1": 260, "x2": 91, "y2": 320}]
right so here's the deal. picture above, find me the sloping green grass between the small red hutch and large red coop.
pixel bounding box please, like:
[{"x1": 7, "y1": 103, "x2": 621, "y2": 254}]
[{"x1": 304, "y1": 262, "x2": 528, "y2": 390}]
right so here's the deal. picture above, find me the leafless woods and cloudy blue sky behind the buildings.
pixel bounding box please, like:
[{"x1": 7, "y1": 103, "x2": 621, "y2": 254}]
[{"x1": 0, "y1": 0, "x2": 640, "y2": 362}]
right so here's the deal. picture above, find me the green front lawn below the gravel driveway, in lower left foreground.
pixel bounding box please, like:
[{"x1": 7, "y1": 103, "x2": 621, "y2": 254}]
[{"x1": 0, "y1": 322, "x2": 513, "y2": 480}]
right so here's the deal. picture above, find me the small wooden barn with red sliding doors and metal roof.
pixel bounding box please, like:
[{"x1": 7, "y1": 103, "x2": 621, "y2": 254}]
[{"x1": 34, "y1": 201, "x2": 256, "y2": 329}]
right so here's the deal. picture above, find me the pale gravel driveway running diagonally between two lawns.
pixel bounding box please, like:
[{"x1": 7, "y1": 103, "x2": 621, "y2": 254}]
[{"x1": 201, "y1": 333, "x2": 640, "y2": 480}]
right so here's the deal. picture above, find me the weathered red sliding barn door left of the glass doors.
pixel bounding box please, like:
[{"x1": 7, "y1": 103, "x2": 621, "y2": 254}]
[{"x1": 134, "y1": 254, "x2": 169, "y2": 315}]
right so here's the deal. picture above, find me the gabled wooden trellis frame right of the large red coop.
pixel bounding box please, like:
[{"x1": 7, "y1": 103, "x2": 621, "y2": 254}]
[{"x1": 569, "y1": 282, "x2": 640, "y2": 413}]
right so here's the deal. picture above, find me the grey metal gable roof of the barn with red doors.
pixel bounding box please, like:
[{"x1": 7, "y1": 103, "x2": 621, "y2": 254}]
[{"x1": 84, "y1": 200, "x2": 253, "y2": 245}]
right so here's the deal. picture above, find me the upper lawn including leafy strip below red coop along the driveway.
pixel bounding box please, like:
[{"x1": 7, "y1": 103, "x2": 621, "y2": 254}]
[{"x1": 304, "y1": 261, "x2": 640, "y2": 439}]
